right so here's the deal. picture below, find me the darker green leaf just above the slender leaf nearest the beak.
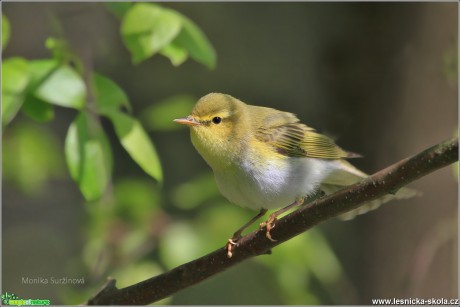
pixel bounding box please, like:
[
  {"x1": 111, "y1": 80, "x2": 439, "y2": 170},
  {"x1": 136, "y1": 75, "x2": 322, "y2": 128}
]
[{"x1": 93, "y1": 73, "x2": 131, "y2": 114}]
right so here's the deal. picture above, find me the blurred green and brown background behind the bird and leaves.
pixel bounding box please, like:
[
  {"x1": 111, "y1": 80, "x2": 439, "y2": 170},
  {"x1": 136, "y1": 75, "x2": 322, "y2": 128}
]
[{"x1": 2, "y1": 2, "x2": 458, "y2": 305}]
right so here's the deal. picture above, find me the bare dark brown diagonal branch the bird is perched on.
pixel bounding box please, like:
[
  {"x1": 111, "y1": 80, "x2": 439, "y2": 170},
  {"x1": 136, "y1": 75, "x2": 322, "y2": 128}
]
[{"x1": 88, "y1": 139, "x2": 458, "y2": 305}]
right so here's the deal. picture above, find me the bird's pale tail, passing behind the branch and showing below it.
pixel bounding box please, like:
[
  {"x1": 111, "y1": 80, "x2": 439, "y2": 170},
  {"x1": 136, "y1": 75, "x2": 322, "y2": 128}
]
[{"x1": 320, "y1": 160, "x2": 421, "y2": 220}]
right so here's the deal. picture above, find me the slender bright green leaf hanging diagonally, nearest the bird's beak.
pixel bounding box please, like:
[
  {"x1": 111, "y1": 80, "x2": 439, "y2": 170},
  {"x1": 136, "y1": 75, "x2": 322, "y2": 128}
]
[{"x1": 110, "y1": 112, "x2": 163, "y2": 182}]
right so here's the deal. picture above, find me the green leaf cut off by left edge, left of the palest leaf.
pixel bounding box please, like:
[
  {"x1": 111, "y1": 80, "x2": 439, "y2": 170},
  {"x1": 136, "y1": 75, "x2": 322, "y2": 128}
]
[{"x1": 2, "y1": 58, "x2": 30, "y2": 126}]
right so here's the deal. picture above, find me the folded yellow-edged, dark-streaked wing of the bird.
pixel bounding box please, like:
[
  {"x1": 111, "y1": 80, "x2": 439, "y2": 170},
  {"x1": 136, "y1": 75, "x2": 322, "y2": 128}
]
[{"x1": 256, "y1": 118, "x2": 352, "y2": 159}]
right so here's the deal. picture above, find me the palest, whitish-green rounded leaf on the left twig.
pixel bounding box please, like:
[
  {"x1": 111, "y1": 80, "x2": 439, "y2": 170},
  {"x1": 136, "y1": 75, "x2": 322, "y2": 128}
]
[{"x1": 35, "y1": 65, "x2": 86, "y2": 109}]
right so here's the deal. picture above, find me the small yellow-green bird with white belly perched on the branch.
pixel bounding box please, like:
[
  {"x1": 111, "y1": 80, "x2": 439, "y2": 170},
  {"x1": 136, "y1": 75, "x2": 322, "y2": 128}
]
[{"x1": 174, "y1": 93, "x2": 417, "y2": 258}]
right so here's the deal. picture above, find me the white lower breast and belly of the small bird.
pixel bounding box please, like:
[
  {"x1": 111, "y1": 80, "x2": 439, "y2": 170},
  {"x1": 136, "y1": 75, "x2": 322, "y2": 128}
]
[{"x1": 214, "y1": 158, "x2": 337, "y2": 210}]
